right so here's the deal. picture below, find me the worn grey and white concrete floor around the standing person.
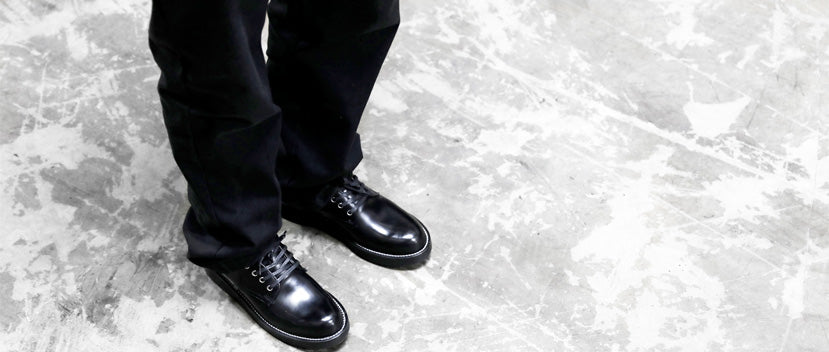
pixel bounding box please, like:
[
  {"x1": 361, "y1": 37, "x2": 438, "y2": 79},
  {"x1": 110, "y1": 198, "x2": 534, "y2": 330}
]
[{"x1": 0, "y1": 0, "x2": 829, "y2": 352}]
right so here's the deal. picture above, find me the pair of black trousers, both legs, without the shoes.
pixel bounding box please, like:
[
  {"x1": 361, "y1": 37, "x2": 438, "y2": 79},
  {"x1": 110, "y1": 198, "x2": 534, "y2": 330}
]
[{"x1": 149, "y1": 0, "x2": 400, "y2": 271}]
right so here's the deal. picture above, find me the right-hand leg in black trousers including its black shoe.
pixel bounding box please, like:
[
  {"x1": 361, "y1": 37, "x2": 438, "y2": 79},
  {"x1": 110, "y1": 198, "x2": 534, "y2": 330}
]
[{"x1": 268, "y1": 0, "x2": 431, "y2": 268}]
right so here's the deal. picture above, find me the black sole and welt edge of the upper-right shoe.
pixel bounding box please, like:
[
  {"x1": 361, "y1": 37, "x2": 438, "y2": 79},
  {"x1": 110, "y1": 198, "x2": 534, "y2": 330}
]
[{"x1": 282, "y1": 204, "x2": 432, "y2": 269}]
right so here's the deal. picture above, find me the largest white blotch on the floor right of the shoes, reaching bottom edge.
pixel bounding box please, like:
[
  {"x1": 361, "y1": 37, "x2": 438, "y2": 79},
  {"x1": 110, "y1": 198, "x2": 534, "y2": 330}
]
[{"x1": 571, "y1": 148, "x2": 727, "y2": 352}]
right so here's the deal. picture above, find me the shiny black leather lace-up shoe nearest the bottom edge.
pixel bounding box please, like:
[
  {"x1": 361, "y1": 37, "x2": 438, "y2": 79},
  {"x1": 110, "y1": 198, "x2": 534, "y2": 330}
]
[{"x1": 206, "y1": 234, "x2": 348, "y2": 349}]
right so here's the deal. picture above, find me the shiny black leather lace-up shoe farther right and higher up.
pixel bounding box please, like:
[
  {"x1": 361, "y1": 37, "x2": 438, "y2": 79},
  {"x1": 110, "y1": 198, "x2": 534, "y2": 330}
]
[{"x1": 282, "y1": 174, "x2": 432, "y2": 268}]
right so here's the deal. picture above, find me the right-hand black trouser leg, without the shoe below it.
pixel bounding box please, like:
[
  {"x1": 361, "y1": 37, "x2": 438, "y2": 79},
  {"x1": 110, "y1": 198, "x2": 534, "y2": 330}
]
[{"x1": 268, "y1": 0, "x2": 400, "y2": 195}]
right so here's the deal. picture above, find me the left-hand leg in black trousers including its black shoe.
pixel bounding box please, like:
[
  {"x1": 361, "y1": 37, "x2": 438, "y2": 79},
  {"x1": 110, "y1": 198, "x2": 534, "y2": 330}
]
[{"x1": 150, "y1": 0, "x2": 349, "y2": 348}]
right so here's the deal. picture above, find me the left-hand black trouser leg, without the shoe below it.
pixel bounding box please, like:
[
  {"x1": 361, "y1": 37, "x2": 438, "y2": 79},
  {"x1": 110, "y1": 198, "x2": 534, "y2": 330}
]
[{"x1": 149, "y1": 0, "x2": 281, "y2": 271}]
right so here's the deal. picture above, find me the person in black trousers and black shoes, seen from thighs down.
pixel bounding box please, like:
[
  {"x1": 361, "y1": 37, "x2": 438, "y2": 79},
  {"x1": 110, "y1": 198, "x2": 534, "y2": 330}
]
[{"x1": 149, "y1": 0, "x2": 431, "y2": 348}]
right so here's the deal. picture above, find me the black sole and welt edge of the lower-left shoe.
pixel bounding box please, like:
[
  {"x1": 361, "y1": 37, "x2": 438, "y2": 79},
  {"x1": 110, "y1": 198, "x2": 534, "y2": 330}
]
[{"x1": 205, "y1": 270, "x2": 349, "y2": 349}]
